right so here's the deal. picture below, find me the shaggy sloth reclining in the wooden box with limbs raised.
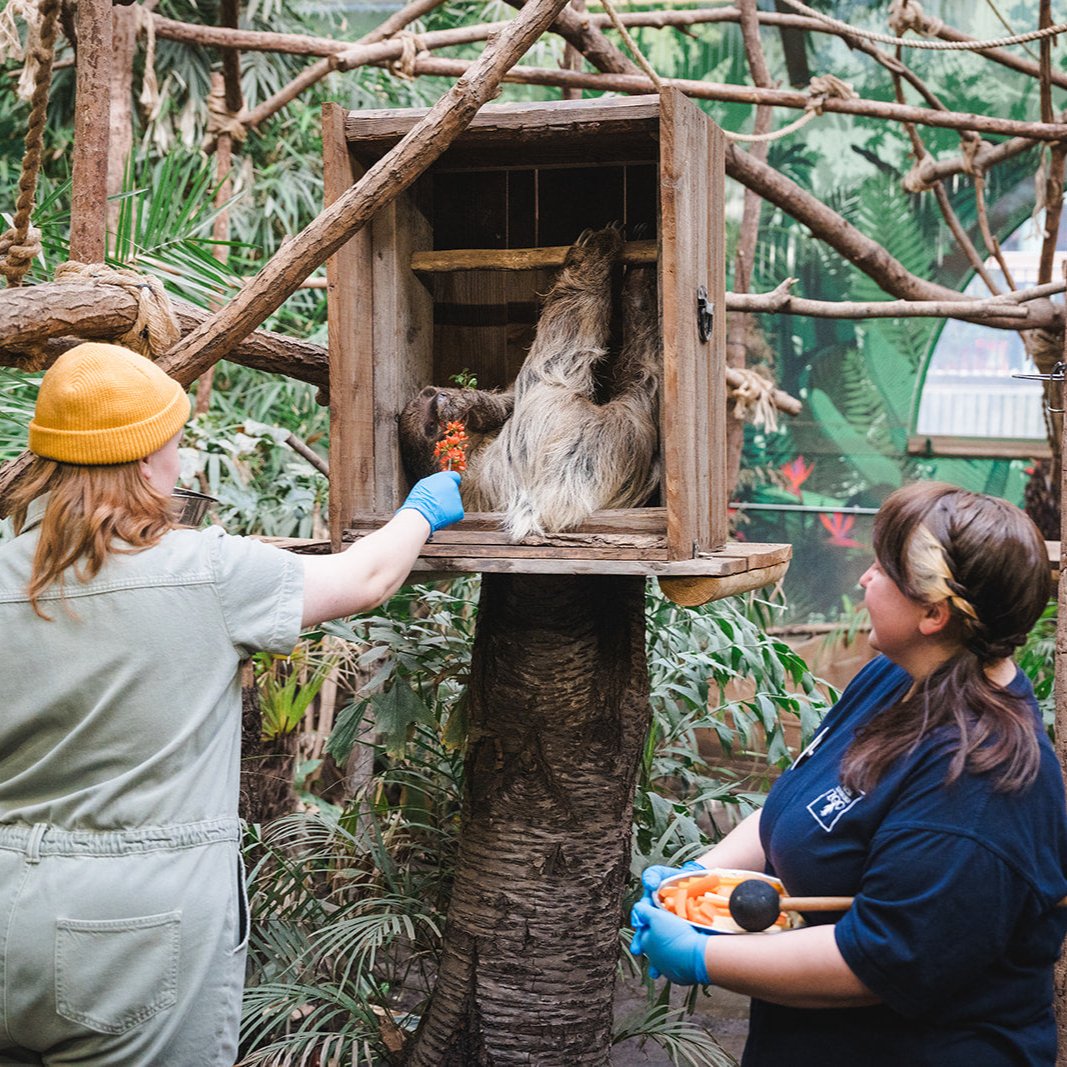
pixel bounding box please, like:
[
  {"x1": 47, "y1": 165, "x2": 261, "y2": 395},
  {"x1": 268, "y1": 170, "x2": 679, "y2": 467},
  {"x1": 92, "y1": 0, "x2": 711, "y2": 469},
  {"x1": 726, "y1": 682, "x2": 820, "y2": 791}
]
[{"x1": 398, "y1": 226, "x2": 663, "y2": 541}]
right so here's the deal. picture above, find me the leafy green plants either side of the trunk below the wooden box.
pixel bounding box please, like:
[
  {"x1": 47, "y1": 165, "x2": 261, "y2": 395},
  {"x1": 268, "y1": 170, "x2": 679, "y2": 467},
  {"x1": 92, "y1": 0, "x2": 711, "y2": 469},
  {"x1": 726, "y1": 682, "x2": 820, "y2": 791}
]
[{"x1": 244, "y1": 579, "x2": 833, "y2": 1067}]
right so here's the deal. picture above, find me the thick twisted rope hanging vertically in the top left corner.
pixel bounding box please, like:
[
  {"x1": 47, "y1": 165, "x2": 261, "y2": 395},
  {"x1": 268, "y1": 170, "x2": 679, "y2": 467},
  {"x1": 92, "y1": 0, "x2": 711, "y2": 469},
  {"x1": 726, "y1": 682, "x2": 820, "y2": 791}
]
[{"x1": 0, "y1": 0, "x2": 60, "y2": 288}]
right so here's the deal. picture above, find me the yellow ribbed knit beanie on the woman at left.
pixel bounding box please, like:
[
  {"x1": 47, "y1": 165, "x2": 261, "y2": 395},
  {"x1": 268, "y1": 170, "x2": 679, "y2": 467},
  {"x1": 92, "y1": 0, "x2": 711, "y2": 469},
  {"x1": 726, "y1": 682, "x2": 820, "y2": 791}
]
[{"x1": 30, "y1": 341, "x2": 189, "y2": 465}]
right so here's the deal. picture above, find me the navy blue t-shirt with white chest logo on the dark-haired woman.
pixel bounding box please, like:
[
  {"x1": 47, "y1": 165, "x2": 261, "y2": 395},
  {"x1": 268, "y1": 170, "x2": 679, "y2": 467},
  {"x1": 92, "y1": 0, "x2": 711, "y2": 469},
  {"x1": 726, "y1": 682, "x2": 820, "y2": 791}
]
[{"x1": 743, "y1": 657, "x2": 1067, "y2": 1067}]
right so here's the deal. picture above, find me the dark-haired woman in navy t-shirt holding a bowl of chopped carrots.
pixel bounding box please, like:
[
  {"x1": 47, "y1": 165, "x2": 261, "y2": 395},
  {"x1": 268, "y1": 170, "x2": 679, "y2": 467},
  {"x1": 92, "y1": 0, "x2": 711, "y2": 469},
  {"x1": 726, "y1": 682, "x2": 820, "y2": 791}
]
[{"x1": 633, "y1": 482, "x2": 1067, "y2": 1067}]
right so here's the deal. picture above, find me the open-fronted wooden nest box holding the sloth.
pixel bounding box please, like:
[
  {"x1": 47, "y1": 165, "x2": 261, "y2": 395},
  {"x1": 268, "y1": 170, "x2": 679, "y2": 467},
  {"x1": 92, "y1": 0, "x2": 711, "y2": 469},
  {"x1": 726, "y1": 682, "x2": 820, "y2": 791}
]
[{"x1": 322, "y1": 90, "x2": 790, "y2": 603}]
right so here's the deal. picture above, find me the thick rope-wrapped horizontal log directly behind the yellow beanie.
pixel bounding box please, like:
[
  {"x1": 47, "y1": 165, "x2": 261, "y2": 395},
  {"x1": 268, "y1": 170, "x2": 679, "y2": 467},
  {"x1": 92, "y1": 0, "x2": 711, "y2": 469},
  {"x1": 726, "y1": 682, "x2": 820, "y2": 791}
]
[{"x1": 0, "y1": 280, "x2": 329, "y2": 391}]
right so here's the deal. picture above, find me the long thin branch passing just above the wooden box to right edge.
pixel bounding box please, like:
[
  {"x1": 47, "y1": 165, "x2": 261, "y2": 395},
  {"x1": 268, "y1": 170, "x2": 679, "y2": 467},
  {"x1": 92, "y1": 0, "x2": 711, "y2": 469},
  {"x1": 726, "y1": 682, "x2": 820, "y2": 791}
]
[{"x1": 399, "y1": 55, "x2": 1067, "y2": 141}]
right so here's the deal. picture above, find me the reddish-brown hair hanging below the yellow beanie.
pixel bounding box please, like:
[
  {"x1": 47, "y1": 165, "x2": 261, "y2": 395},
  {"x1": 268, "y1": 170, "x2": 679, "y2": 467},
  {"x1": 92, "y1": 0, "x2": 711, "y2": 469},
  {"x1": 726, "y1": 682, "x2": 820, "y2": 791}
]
[{"x1": 10, "y1": 457, "x2": 176, "y2": 619}]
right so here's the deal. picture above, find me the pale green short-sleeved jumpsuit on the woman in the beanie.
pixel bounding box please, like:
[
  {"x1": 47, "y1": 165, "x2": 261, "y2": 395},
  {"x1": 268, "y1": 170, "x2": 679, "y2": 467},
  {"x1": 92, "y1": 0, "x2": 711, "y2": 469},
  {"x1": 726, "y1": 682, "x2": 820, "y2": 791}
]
[{"x1": 0, "y1": 498, "x2": 303, "y2": 1067}]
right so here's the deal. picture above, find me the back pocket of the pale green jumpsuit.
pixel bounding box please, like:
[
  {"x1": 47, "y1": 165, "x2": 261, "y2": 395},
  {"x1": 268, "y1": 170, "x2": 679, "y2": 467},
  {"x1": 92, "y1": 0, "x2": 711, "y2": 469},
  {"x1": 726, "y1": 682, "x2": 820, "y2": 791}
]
[{"x1": 55, "y1": 911, "x2": 181, "y2": 1034}]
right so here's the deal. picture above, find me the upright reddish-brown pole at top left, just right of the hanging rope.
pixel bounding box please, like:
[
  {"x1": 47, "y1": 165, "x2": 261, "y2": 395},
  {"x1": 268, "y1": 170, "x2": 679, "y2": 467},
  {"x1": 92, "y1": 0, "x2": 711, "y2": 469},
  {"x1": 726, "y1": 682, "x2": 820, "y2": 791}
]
[{"x1": 70, "y1": 0, "x2": 112, "y2": 264}]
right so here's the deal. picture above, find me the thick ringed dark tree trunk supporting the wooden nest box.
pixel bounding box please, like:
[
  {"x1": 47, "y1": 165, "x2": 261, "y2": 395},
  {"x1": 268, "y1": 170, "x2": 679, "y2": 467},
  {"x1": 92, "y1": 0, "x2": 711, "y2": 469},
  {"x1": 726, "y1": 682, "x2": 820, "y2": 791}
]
[{"x1": 408, "y1": 574, "x2": 650, "y2": 1067}]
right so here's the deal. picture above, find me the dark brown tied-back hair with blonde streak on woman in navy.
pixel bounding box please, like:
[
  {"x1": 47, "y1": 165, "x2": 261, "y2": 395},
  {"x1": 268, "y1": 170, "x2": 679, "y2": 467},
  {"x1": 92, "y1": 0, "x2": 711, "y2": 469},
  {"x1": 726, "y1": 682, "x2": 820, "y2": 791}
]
[{"x1": 842, "y1": 482, "x2": 1051, "y2": 793}]
